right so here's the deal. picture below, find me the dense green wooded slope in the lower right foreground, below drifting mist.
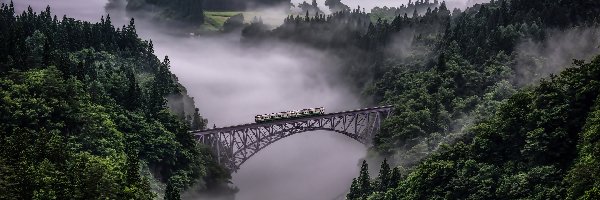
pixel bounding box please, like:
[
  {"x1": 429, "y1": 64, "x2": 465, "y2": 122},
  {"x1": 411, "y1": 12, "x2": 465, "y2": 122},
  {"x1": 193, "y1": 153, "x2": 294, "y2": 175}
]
[{"x1": 348, "y1": 56, "x2": 600, "y2": 199}]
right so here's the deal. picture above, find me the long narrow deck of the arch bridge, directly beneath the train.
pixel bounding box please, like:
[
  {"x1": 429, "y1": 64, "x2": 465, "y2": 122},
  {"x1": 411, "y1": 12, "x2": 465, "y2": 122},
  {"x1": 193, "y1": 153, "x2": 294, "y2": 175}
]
[{"x1": 190, "y1": 105, "x2": 393, "y2": 135}]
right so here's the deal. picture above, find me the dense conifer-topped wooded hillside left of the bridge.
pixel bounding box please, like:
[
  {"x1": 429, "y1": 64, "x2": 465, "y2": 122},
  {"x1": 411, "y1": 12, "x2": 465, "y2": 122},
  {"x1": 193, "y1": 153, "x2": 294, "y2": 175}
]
[{"x1": 0, "y1": 4, "x2": 230, "y2": 199}]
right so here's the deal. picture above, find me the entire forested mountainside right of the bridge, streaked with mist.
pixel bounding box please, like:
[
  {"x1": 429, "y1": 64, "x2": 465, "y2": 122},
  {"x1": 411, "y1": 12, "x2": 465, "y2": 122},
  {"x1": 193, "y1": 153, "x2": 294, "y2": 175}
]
[{"x1": 243, "y1": 0, "x2": 600, "y2": 199}]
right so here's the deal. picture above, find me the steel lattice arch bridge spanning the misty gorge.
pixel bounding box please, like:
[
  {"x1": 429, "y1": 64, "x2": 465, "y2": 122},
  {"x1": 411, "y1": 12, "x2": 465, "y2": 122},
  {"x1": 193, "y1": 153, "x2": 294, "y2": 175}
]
[{"x1": 191, "y1": 106, "x2": 392, "y2": 171}]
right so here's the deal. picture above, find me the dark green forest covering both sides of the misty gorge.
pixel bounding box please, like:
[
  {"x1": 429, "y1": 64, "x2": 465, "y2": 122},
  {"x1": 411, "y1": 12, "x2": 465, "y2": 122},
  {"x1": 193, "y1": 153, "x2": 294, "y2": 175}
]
[{"x1": 0, "y1": 0, "x2": 600, "y2": 200}]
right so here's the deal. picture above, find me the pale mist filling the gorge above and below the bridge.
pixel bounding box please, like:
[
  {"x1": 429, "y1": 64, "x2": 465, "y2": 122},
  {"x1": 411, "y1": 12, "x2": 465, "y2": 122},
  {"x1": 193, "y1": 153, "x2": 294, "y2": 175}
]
[{"x1": 2, "y1": 0, "x2": 366, "y2": 200}]
